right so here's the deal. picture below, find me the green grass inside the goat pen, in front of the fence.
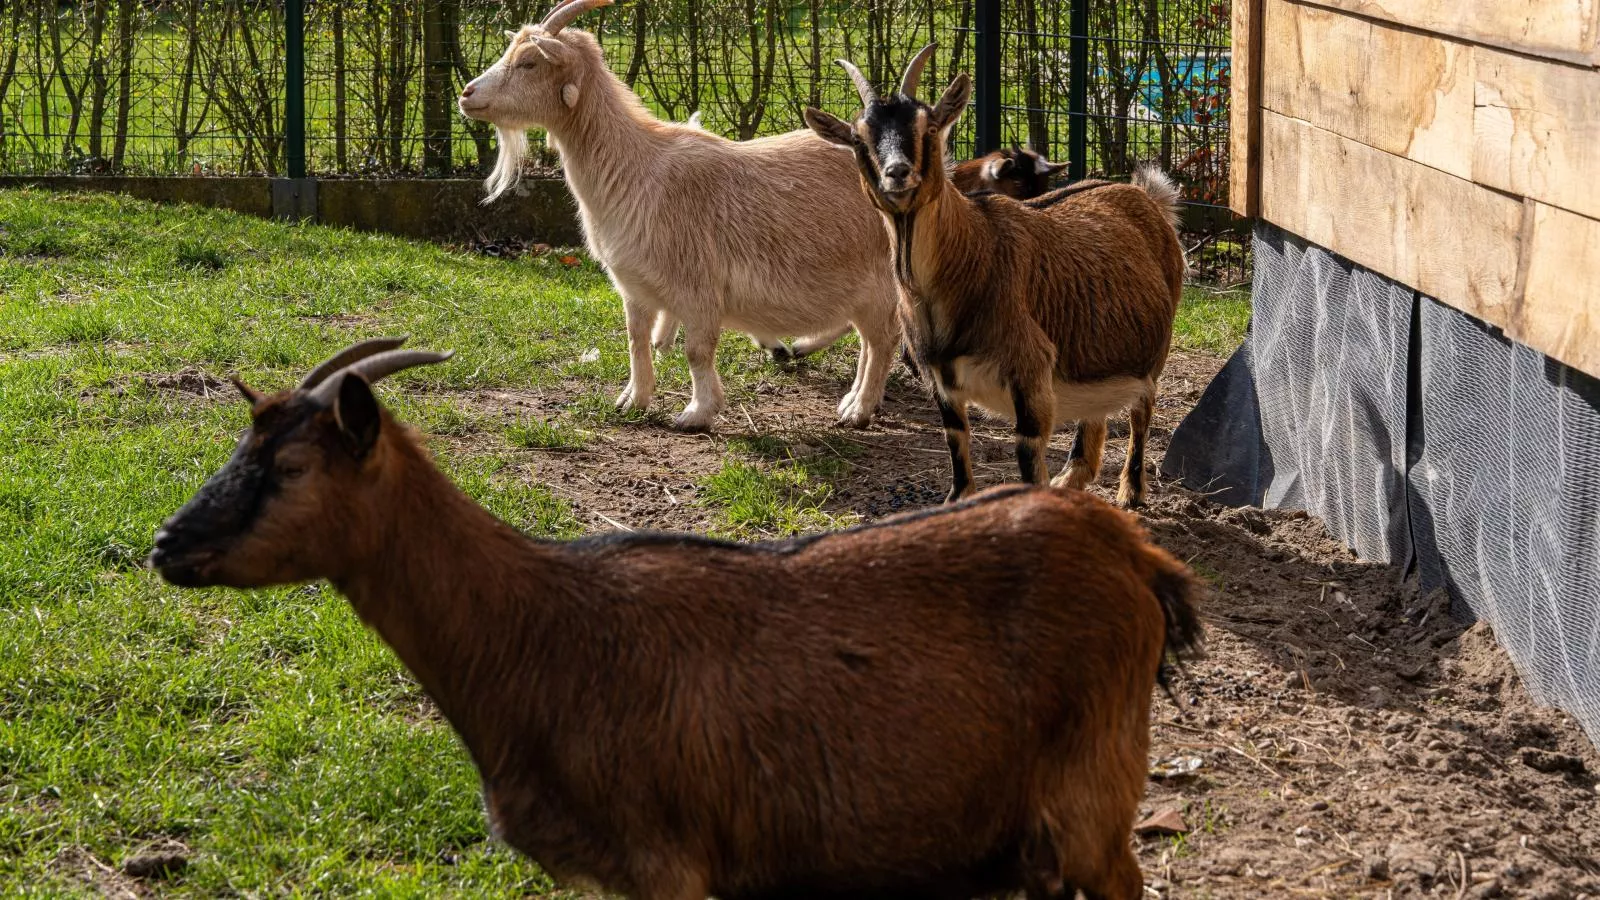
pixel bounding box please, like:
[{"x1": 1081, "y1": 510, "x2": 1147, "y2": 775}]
[{"x1": 0, "y1": 191, "x2": 1246, "y2": 897}]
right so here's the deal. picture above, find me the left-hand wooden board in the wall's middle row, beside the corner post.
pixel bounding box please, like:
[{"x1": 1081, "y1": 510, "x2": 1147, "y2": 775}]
[{"x1": 1261, "y1": 0, "x2": 1474, "y2": 178}]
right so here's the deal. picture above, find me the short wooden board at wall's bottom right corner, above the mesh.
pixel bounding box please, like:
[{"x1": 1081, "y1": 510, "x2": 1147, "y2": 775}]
[{"x1": 1506, "y1": 200, "x2": 1600, "y2": 376}]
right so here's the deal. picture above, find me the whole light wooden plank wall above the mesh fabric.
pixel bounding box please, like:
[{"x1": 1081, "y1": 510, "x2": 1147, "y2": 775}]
[{"x1": 1234, "y1": 0, "x2": 1600, "y2": 376}]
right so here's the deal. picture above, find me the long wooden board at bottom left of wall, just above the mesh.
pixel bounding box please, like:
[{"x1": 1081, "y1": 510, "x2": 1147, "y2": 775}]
[{"x1": 1261, "y1": 110, "x2": 1523, "y2": 329}]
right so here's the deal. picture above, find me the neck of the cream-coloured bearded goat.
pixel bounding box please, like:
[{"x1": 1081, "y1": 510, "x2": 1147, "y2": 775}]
[{"x1": 549, "y1": 62, "x2": 661, "y2": 211}]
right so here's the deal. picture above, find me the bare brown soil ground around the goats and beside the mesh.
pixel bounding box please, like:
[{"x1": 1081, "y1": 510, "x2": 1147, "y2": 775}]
[{"x1": 441, "y1": 347, "x2": 1600, "y2": 900}]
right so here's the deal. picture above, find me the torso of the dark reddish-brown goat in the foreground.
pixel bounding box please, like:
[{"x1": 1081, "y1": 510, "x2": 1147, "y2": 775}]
[{"x1": 491, "y1": 488, "x2": 1181, "y2": 900}]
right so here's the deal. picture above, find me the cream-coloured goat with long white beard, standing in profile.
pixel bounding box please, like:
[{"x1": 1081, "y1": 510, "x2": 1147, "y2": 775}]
[{"x1": 458, "y1": 0, "x2": 899, "y2": 431}]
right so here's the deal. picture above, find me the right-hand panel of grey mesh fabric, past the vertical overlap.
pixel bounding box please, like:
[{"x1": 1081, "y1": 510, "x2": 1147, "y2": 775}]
[{"x1": 1410, "y1": 299, "x2": 1600, "y2": 738}]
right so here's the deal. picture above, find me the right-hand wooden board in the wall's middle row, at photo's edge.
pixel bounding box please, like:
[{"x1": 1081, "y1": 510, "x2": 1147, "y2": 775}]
[{"x1": 1470, "y1": 48, "x2": 1600, "y2": 222}]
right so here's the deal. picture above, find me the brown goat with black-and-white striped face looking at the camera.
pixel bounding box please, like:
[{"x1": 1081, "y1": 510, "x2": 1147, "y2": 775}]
[{"x1": 805, "y1": 43, "x2": 1187, "y2": 506}]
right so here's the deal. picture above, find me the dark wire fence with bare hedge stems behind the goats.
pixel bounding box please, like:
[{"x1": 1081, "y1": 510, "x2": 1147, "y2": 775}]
[{"x1": 0, "y1": 0, "x2": 1246, "y2": 280}]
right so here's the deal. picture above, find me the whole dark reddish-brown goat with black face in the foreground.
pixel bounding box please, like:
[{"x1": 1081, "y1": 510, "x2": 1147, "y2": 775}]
[{"x1": 150, "y1": 340, "x2": 1202, "y2": 900}]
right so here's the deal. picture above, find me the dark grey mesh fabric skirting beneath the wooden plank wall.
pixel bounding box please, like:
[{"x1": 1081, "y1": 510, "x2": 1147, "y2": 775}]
[{"x1": 1163, "y1": 224, "x2": 1600, "y2": 738}]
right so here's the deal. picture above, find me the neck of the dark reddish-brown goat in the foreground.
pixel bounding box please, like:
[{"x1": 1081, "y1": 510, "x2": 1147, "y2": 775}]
[{"x1": 334, "y1": 437, "x2": 558, "y2": 773}]
